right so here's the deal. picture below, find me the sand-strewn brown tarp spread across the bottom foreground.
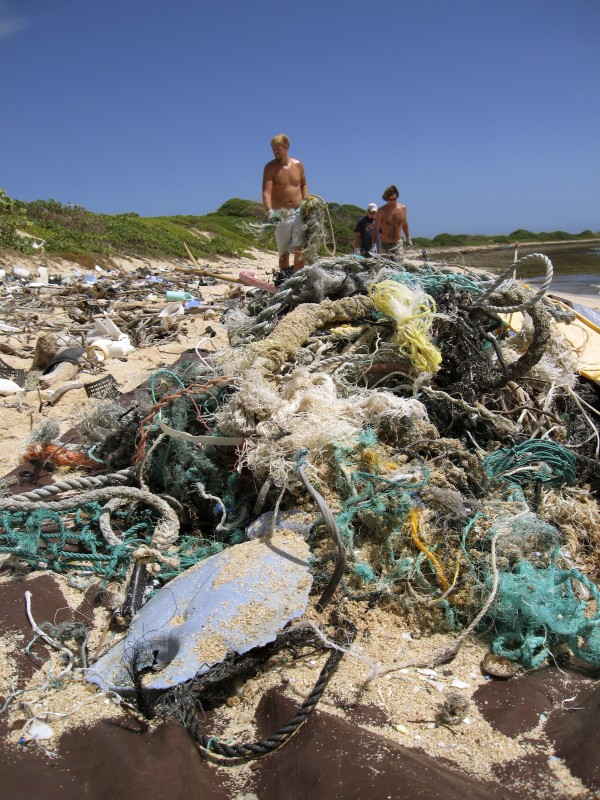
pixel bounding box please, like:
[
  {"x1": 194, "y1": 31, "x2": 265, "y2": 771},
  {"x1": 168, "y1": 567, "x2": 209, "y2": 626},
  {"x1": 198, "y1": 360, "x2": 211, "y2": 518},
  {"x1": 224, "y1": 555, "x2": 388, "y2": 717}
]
[{"x1": 0, "y1": 575, "x2": 600, "y2": 800}]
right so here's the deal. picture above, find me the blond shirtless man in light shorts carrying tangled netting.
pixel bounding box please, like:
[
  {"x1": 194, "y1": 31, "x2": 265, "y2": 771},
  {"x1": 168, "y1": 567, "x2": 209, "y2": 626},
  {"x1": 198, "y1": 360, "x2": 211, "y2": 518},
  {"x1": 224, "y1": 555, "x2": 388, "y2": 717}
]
[{"x1": 263, "y1": 133, "x2": 308, "y2": 272}]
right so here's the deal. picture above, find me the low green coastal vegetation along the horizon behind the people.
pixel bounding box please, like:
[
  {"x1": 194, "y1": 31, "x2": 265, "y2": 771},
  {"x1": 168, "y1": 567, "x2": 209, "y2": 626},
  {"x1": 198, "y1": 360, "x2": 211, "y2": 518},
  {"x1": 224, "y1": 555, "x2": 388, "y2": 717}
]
[{"x1": 0, "y1": 189, "x2": 600, "y2": 263}]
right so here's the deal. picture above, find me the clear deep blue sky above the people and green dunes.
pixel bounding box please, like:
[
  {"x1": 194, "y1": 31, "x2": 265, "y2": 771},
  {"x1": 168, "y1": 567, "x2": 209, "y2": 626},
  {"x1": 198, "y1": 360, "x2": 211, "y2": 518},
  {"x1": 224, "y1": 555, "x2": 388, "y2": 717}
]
[{"x1": 0, "y1": 0, "x2": 600, "y2": 236}]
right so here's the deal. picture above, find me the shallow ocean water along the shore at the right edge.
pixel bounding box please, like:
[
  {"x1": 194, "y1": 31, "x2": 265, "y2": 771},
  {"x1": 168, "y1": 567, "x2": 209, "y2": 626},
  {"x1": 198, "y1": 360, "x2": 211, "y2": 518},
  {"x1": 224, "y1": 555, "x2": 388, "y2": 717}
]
[{"x1": 449, "y1": 242, "x2": 600, "y2": 306}]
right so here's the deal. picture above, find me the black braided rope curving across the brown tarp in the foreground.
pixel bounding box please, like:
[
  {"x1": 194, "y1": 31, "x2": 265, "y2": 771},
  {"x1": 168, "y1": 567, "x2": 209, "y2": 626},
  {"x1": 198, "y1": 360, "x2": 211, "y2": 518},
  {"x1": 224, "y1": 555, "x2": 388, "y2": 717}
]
[{"x1": 183, "y1": 620, "x2": 356, "y2": 766}]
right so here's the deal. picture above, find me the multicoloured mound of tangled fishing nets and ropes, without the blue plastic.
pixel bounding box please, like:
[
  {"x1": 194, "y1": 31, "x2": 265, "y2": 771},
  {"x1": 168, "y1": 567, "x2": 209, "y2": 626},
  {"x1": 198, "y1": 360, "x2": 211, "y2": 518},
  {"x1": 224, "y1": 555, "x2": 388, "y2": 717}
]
[{"x1": 0, "y1": 252, "x2": 600, "y2": 667}]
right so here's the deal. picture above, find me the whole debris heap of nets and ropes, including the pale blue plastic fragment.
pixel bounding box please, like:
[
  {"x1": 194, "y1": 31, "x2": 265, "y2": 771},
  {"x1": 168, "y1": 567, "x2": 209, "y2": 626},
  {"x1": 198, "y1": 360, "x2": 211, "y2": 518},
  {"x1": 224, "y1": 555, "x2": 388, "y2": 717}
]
[{"x1": 0, "y1": 255, "x2": 600, "y2": 759}]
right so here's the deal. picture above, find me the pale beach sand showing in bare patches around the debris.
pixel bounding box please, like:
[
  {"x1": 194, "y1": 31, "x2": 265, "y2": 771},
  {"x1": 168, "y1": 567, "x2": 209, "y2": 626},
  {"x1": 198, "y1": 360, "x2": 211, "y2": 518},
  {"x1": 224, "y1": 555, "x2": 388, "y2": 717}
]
[{"x1": 0, "y1": 250, "x2": 600, "y2": 800}]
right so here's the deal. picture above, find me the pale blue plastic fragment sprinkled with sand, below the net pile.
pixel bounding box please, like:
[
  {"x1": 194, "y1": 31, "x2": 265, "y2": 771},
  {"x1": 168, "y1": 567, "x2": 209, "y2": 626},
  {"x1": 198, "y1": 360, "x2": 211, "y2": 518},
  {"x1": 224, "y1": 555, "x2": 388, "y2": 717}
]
[{"x1": 86, "y1": 529, "x2": 312, "y2": 693}]
